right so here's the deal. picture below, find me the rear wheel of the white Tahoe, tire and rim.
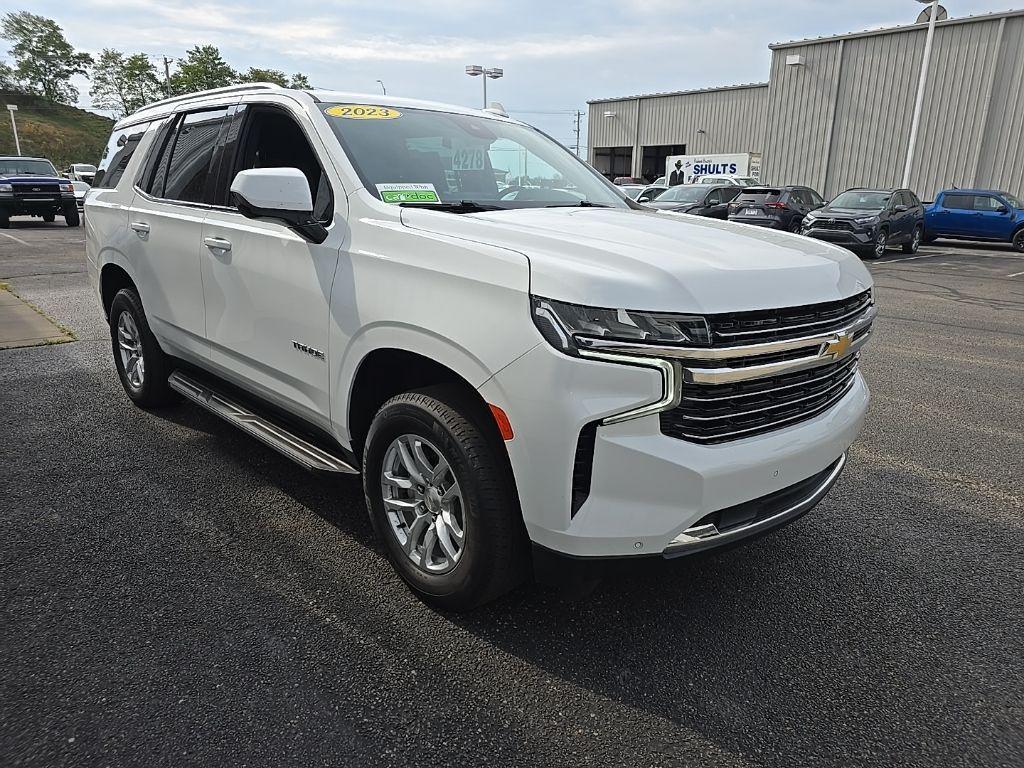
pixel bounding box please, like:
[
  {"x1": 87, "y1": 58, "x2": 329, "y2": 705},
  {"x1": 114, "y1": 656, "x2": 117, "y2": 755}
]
[{"x1": 110, "y1": 288, "x2": 178, "y2": 408}]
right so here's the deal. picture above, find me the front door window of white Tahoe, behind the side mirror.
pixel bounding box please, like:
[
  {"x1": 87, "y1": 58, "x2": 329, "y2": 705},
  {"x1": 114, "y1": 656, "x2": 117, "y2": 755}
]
[{"x1": 225, "y1": 105, "x2": 334, "y2": 224}]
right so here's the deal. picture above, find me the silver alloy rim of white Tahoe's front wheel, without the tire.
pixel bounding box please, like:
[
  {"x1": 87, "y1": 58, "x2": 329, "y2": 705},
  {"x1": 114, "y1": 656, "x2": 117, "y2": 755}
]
[{"x1": 381, "y1": 434, "x2": 466, "y2": 574}]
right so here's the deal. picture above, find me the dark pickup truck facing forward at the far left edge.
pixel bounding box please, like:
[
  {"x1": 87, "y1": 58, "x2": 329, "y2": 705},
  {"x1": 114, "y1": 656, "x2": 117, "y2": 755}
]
[{"x1": 0, "y1": 157, "x2": 79, "y2": 228}]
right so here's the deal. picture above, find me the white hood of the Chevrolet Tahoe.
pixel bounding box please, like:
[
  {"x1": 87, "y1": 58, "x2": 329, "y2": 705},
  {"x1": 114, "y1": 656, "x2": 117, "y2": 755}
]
[{"x1": 401, "y1": 208, "x2": 871, "y2": 313}]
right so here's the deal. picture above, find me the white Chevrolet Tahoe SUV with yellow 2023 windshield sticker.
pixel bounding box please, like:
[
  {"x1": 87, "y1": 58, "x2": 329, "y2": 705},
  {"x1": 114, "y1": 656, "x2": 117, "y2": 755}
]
[{"x1": 85, "y1": 85, "x2": 876, "y2": 608}]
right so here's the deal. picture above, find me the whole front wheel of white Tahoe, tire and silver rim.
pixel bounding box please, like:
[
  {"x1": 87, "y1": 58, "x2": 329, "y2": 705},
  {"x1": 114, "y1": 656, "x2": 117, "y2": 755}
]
[{"x1": 362, "y1": 387, "x2": 526, "y2": 610}]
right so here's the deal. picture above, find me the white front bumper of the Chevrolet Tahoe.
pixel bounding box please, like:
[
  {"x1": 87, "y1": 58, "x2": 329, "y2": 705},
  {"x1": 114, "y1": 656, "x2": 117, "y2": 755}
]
[{"x1": 480, "y1": 344, "x2": 869, "y2": 557}]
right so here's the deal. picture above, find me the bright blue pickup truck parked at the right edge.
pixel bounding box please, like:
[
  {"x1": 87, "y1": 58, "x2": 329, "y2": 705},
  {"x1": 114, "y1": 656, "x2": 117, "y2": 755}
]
[{"x1": 925, "y1": 189, "x2": 1024, "y2": 252}]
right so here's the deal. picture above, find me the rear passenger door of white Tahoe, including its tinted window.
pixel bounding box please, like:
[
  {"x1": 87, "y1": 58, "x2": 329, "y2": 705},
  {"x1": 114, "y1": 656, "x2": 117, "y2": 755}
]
[{"x1": 128, "y1": 104, "x2": 229, "y2": 361}]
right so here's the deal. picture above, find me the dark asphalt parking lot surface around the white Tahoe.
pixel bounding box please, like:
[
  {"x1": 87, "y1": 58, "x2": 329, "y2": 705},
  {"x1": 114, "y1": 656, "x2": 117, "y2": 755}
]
[{"x1": 0, "y1": 221, "x2": 1024, "y2": 768}]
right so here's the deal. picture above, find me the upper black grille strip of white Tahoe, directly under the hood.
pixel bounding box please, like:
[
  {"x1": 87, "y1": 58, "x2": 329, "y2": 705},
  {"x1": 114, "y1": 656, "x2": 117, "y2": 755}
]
[{"x1": 708, "y1": 291, "x2": 871, "y2": 346}]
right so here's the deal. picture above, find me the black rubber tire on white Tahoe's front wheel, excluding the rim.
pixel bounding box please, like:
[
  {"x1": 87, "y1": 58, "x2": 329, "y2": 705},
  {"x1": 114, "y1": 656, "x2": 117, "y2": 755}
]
[{"x1": 362, "y1": 387, "x2": 528, "y2": 610}]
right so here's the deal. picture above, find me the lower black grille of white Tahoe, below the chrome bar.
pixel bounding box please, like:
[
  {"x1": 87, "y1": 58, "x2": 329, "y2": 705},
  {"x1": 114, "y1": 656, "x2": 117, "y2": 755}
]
[{"x1": 660, "y1": 352, "x2": 859, "y2": 443}]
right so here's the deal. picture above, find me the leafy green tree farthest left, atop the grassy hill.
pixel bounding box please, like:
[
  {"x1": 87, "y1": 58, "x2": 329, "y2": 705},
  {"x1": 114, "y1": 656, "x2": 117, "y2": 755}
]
[{"x1": 0, "y1": 10, "x2": 92, "y2": 103}]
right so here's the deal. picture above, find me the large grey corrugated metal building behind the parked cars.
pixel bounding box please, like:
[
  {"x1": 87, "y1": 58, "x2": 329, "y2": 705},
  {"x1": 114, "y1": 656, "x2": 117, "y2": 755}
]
[{"x1": 588, "y1": 10, "x2": 1024, "y2": 200}]
